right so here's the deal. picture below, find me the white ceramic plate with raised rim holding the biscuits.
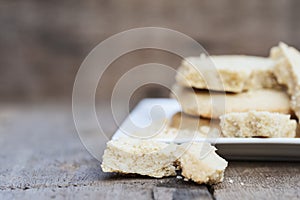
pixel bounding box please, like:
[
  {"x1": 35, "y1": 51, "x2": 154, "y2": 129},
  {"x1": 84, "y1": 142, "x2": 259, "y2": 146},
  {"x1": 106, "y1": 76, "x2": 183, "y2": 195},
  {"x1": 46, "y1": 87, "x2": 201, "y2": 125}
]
[{"x1": 112, "y1": 99, "x2": 300, "y2": 161}]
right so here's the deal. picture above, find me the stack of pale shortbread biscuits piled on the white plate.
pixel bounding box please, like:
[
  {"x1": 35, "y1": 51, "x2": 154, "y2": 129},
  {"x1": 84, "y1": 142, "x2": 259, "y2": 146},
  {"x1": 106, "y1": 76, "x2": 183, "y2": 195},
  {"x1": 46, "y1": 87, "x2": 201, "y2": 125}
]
[{"x1": 171, "y1": 43, "x2": 300, "y2": 137}]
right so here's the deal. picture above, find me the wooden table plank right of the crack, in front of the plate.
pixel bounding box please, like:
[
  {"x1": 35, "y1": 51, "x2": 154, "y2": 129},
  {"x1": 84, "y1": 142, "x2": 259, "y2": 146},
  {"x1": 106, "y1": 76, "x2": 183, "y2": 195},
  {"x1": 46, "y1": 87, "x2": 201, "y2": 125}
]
[{"x1": 212, "y1": 161, "x2": 300, "y2": 199}]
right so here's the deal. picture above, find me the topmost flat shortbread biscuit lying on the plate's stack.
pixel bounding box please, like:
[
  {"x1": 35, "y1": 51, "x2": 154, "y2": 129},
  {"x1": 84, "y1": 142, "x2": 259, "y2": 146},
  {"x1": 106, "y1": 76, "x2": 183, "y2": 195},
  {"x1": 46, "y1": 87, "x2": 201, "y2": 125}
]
[{"x1": 176, "y1": 54, "x2": 279, "y2": 93}]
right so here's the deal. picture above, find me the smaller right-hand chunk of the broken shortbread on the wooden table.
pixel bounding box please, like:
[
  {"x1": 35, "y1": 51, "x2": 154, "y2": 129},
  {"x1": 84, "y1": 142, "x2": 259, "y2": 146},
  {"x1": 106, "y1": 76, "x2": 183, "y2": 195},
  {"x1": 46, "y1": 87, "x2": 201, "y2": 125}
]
[{"x1": 178, "y1": 142, "x2": 228, "y2": 184}]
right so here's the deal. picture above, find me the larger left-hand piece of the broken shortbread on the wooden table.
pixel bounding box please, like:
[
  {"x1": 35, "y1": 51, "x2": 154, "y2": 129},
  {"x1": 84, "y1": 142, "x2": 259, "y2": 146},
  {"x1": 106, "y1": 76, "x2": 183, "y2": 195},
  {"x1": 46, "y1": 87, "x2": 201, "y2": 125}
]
[{"x1": 101, "y1": 138, "x2": 177, "y2": 178}]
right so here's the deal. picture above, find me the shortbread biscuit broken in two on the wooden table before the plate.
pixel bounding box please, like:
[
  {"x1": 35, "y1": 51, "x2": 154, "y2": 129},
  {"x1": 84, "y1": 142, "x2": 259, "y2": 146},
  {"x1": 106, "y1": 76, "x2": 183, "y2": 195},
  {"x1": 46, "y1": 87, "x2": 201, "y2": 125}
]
[{"x1": 101, "y1": 138, "x2": 227, "y2": 184}]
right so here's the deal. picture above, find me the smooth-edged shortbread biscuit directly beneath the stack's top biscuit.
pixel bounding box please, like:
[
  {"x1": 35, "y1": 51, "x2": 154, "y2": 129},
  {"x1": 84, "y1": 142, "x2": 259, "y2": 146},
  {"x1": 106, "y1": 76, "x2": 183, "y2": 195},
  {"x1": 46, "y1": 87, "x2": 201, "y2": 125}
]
[{"x1": 171, "y1": 85, "x2": 292, "y2": 118}]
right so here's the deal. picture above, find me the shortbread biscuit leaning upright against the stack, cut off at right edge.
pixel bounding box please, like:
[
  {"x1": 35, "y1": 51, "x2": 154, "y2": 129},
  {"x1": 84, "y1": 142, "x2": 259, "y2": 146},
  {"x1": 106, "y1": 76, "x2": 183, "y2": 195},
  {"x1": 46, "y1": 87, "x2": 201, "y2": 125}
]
[{"x1": 270, "y1": 43, "x2": 300, "y2": 119}]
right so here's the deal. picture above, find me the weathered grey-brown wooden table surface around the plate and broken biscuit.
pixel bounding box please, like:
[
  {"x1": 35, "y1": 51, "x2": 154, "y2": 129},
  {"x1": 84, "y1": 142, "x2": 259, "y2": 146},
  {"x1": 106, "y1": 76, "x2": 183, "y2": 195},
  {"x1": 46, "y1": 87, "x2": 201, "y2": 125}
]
[{"x1": 0, "y1": 104, "x2": 300, "y2": 199}]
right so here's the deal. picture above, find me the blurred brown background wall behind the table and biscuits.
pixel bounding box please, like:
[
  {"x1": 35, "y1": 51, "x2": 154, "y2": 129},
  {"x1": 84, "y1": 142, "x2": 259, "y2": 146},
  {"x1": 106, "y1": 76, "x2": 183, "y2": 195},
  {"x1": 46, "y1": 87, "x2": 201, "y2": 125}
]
[{"x1": 0, "y1": 0, "x2": 300, "y2": 102}]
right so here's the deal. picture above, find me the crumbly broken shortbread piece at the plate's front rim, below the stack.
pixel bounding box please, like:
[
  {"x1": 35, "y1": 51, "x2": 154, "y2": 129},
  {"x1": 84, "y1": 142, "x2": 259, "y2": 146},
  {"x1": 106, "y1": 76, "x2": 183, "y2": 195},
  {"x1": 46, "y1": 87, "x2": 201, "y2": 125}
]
[{"x1": 220, "y1": 111, "x2": 297, "y2": 138}]
